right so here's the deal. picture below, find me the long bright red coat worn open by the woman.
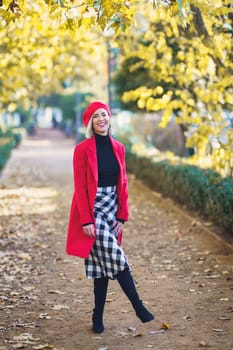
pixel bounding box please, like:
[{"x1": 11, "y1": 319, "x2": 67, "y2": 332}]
[{"x1": 66, "y1": 137, "x2": 128, "y2": 258}]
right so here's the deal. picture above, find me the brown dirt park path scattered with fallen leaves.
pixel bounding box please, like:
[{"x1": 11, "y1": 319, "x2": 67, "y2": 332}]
[{"x1": 0, "y1": 129, "x2": 233, "y2": 350}]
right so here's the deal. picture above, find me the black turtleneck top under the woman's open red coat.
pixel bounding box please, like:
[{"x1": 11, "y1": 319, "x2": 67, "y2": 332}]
[{"x1": 95, "y1": 134, "x2": 120, "y2": 187}]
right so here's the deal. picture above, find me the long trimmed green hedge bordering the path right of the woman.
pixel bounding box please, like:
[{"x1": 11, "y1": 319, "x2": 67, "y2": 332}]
[{"x1": 126, "y1": 144, "x2": 233, "y2": 233}]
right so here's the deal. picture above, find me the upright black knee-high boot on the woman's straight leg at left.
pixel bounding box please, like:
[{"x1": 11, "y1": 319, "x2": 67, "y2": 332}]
[{"x1": 92, "y1": 277, "x2": 108, "y2": 333}]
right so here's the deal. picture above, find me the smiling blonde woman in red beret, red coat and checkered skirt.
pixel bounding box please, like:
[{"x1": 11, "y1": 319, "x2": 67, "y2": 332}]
[{"x1": 67, "y1": 101, "x2": 154, "y2": 333}]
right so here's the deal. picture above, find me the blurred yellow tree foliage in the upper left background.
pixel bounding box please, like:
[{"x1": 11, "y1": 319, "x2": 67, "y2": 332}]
[{"x1": 0, "y1": 1, "x2": 110, "y2": 115}]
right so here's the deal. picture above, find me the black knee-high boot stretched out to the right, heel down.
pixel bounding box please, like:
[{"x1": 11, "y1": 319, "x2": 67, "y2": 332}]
[{"x1": 116, "y1": 269, "x2": 154, "y2": 322}]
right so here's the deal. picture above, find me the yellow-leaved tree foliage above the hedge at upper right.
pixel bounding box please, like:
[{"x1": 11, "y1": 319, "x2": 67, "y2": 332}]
[{"x1": 116, "y1": 2, "x2": 233, "y2": 176}]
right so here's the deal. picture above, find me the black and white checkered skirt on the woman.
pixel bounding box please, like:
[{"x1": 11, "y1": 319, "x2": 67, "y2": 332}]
[{"x1": 85, "y1": 186, "x2": 130, "y2": 279}]
